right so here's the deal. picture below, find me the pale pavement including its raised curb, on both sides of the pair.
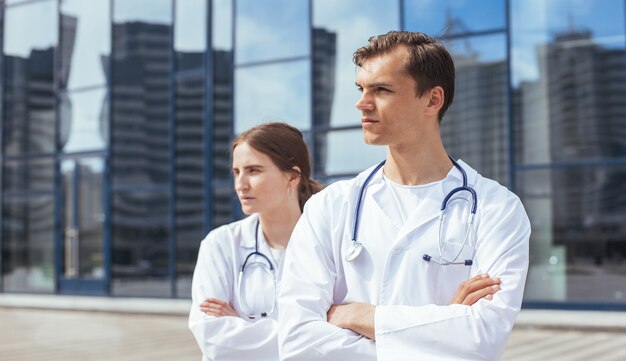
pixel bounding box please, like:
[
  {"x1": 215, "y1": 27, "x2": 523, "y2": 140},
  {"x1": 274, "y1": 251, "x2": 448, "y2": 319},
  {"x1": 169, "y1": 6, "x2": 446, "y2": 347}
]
[{"x1": 0, "y1": 294, "x2": 626, "y2": 361}]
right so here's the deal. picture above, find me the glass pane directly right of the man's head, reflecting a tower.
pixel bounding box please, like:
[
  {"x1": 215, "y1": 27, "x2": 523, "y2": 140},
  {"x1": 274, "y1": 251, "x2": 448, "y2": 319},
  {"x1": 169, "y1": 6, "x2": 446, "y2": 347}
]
[{"x1": 441, "y1": 35, "x2": 509, "y2": 184}]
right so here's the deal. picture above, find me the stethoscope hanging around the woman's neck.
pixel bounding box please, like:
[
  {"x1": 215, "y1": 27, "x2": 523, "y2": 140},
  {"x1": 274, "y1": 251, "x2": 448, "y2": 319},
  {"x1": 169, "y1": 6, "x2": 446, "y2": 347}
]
[{"x1": 237, "y1": 220, "x2": 276, "y2": 320}]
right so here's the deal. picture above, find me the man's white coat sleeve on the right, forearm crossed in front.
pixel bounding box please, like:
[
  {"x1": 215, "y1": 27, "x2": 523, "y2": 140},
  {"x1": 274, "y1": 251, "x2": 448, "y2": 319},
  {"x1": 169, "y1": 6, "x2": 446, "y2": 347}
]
[{"x1": 375, "y1": 191, "x2": 530, "y2": 361}]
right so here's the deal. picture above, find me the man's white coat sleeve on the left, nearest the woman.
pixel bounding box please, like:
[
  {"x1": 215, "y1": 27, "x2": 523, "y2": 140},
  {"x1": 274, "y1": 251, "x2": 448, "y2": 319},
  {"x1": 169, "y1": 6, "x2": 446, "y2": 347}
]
[{"x1": 278, "y1": 196, "x2": 376, "y2": 361}]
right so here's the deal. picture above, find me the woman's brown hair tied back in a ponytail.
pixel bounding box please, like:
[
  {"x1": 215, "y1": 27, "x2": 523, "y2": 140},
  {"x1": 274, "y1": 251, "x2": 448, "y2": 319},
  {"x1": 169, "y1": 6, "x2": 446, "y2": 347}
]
[{"x1": 231, "y1": 123, "x2": 322, "y2": 210}]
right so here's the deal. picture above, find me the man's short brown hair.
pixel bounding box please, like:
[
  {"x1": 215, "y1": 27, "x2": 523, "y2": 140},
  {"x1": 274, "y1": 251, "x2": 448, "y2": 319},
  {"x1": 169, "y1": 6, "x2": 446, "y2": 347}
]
[{"x1": 353, "y1": 31, "x2": 454, "y2": 122}]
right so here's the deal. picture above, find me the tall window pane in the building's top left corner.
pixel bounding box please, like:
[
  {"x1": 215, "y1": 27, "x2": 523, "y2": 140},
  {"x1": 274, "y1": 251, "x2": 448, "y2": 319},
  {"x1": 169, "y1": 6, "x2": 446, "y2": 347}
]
[{"x1": 3, "y1": 1, "x2": 57, "y2": 154}]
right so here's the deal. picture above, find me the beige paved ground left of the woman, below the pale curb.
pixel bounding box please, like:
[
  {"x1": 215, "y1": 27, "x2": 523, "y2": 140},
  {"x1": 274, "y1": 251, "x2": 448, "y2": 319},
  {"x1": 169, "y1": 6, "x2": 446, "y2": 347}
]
[{"x1": 0, "y1": 308, "x2": 201, "y2": 361}]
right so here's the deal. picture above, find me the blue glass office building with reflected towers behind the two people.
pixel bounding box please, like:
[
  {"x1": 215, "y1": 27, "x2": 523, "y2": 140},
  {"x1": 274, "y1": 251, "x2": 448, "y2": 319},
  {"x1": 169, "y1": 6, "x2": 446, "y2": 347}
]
[{"x1": 0, "y1": 0, "x2": 626, "y2": 309}]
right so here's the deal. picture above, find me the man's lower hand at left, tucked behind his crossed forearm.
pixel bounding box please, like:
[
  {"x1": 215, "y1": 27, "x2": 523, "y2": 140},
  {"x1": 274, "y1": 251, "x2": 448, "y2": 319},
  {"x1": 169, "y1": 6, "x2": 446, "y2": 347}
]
[{"x1": 328, "y1": 303, "x2": 376, "y2": 340}]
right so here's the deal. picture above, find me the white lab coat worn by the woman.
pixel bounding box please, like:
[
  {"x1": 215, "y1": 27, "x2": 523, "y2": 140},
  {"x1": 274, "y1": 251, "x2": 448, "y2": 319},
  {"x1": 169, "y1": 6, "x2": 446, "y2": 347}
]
[{"x1": 189, "y1": 215, "x2": 282, "y2": 361}]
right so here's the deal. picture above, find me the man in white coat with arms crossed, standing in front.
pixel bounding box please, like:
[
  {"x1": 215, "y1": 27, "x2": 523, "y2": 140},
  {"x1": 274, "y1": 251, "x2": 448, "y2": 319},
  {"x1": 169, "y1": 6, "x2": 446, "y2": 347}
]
[{"x1": 278, "y1": 32, "x2": 530, "y2": 361}]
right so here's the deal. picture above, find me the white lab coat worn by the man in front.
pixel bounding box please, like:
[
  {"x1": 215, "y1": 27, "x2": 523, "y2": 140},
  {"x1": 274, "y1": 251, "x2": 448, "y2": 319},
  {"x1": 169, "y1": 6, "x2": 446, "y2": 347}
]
[{"x1": 278, "y1": 161, "x2": 530, "y2": 361}]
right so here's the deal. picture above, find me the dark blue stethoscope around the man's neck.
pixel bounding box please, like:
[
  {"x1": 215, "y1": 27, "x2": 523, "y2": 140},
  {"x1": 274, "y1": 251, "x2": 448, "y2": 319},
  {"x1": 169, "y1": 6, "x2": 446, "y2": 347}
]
[{"x1": 344, "y1": 156, "x2": 478, "y2": 266}]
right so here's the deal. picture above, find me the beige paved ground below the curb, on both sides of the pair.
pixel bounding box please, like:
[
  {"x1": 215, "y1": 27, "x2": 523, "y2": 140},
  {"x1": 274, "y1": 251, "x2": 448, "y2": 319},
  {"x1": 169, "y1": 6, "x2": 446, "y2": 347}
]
[{"x1": 0, "y1": 308, "x2": 626, "y2": 361}]
